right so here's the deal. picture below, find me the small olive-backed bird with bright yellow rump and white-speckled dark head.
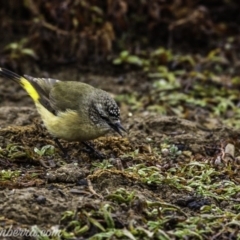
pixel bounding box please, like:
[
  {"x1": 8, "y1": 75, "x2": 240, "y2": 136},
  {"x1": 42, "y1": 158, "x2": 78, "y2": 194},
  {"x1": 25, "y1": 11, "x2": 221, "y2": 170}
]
[{"x1": 0, "y1": 68, "x2": 126, "y2": 155}]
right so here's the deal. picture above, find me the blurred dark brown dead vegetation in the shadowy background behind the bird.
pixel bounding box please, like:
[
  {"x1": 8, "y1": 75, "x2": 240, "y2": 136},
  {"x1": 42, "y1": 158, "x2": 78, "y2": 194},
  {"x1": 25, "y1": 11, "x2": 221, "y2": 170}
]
[{"x1": 0, "y1": 0, "x2": 240, "y2": 71}]
